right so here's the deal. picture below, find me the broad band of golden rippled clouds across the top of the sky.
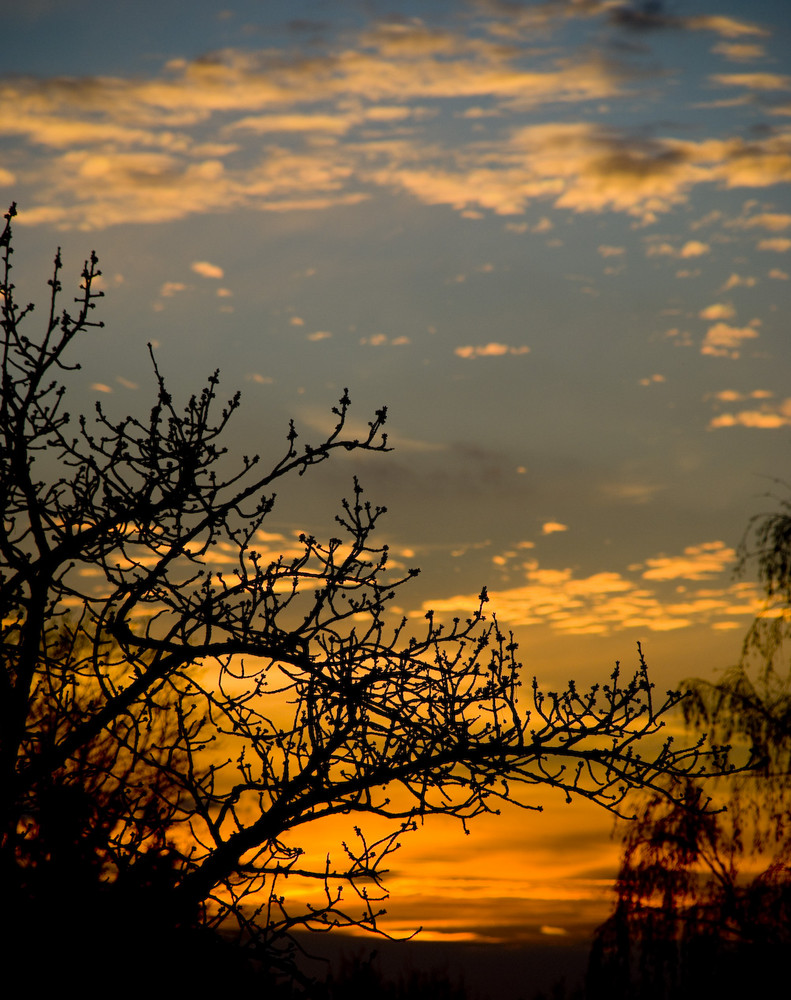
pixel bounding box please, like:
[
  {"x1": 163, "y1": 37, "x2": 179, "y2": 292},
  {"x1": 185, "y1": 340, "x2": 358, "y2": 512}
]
[{"x1": 0, "y1": 17, "x2": 791, "y2": 230}]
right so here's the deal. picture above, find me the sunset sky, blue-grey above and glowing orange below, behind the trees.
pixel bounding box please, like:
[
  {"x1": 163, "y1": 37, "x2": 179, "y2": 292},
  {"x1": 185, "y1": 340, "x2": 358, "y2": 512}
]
[{"x1": 0, "y1": 0, "x2": 791, "y2": 960}]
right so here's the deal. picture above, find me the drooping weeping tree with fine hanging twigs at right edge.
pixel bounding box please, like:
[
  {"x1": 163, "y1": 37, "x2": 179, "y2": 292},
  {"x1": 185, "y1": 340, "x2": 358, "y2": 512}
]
[{"x1": 589, "y1": 480, "x2": 791, "y2": 1000}]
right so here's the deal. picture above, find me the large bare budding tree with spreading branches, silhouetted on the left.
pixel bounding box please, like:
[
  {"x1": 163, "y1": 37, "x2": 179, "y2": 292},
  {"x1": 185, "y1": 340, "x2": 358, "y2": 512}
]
[{"x1": 0, "y1": 206, "x2": 722, "y2": 984}]
